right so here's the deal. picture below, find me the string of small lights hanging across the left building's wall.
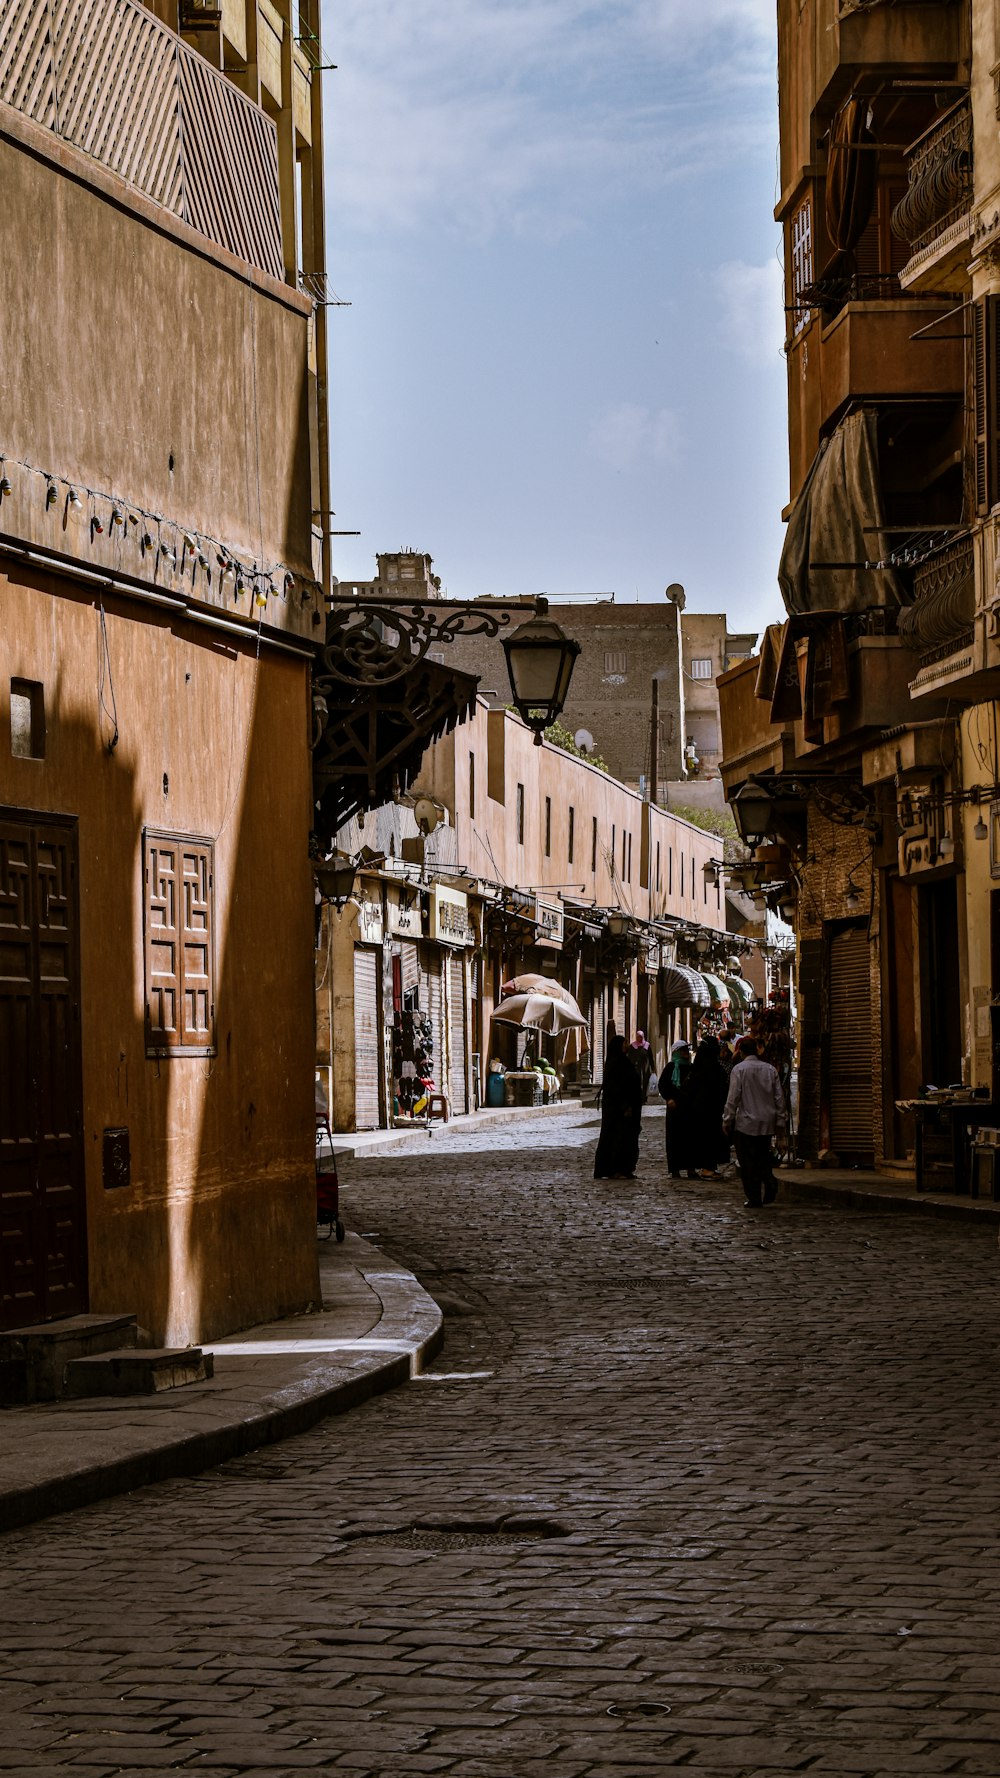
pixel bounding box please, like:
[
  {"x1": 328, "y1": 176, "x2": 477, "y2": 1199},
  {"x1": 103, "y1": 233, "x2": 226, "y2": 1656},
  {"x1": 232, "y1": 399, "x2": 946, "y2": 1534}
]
[{"x1": 0, "y1": 450, "x2": 320, "y2": 610}]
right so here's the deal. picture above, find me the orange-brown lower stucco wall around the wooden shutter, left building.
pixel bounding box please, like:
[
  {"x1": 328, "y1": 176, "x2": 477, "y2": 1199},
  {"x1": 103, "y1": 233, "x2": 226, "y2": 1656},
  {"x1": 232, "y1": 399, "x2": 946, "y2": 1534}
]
[{"x1": 0, "y1": 565, "x2": 319, "y2": 1344}]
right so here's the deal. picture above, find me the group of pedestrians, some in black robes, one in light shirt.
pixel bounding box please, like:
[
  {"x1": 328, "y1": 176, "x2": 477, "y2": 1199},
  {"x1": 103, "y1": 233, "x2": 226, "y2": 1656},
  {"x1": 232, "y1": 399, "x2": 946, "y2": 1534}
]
[{"x1": 594, "y1": 1031, "x2": 786, "y2": 1209}]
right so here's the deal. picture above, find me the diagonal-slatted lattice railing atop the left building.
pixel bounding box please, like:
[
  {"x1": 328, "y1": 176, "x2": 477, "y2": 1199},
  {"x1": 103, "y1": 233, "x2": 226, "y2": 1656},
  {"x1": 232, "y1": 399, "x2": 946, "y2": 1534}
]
[{"x1": 0, "y1": 0, "x2": 285, "y2": 277}]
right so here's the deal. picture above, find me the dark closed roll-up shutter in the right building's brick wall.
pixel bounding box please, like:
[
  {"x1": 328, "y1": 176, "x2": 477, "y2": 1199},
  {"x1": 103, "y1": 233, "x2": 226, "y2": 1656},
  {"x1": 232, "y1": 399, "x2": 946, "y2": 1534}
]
[{"x1": 827, "y1": 926, "x2": 874, "y2": 1161}]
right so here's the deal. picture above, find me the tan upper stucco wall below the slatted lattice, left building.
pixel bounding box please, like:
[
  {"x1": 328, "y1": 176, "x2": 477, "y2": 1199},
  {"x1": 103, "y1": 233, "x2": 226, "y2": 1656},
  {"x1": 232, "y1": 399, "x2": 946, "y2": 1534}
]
[{"x1": 0, "y1": 112, "x2": 313, "y2": 637}]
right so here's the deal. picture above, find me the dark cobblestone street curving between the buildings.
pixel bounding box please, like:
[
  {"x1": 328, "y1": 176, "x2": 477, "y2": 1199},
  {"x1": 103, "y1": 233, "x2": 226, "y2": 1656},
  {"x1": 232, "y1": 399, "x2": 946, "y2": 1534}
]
[{"x1": 0, "y1": 1111, "x2": 1000, "y2": 1778}]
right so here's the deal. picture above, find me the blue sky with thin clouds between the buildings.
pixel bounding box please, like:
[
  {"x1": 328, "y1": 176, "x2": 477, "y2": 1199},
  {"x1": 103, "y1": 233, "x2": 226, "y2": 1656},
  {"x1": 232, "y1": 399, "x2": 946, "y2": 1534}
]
[{"x1": 322, "y1": 0, "x2": 788, "y2": 628}]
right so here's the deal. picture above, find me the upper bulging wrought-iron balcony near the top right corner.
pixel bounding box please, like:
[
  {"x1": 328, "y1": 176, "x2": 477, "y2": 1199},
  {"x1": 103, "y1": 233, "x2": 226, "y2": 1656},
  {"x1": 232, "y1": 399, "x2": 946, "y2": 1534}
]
[{"x1": 891, "y1": 96, "x2": 973, "y2": 290}]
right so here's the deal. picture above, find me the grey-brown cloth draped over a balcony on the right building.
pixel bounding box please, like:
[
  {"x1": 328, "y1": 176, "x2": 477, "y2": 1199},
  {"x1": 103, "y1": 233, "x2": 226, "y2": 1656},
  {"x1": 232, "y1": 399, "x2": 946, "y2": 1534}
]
[{"x1": 778, "y1": 407, "x2": 902, "y2": 613}]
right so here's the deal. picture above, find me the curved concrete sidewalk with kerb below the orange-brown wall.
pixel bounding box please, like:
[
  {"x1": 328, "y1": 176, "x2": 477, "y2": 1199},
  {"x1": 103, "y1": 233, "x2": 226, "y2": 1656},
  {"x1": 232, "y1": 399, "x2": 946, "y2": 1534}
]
[{"x1": 0, "y1": 1234, "x2": 441, "y2": 1531}]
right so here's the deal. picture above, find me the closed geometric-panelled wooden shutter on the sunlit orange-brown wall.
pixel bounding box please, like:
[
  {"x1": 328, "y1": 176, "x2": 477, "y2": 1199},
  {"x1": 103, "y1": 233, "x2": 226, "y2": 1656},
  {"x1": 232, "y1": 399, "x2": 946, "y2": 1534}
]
[{"x1": 144, "y1": 830, "x2": 215, "y2": 1056}]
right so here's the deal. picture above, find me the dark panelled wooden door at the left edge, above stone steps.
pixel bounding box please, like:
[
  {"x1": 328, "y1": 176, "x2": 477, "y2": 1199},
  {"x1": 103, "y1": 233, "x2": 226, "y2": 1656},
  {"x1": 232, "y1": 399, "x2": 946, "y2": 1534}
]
[{"x1": 0, "y1": 816, "x2": 87, "y2": 1328}]
